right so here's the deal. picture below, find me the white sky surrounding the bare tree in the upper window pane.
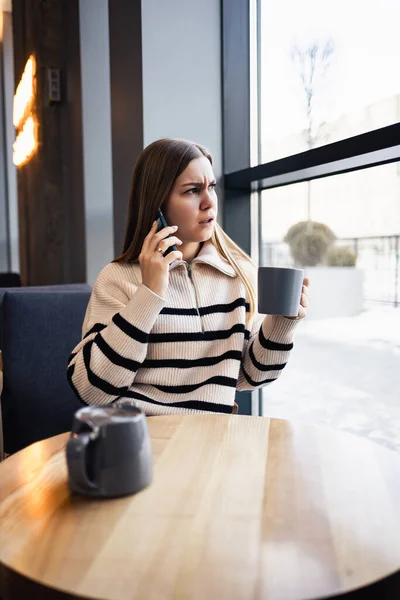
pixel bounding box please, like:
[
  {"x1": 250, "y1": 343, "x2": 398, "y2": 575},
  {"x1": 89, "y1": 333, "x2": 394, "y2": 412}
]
[{"x1": 261, "y1": 0, "x2": 400, "y2": 144}]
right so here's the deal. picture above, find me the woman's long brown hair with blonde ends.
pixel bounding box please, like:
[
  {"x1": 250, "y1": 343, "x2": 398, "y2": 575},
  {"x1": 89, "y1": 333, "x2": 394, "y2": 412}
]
[{"x1": 114, "y1": 138, "x2": 256, "y2": 320}]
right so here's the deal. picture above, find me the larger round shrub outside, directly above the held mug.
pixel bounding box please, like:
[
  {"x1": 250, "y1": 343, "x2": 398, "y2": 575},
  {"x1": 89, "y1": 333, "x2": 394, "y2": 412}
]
[{"x1": 284, "y1": 221, "x2": 336, "y2": 267}]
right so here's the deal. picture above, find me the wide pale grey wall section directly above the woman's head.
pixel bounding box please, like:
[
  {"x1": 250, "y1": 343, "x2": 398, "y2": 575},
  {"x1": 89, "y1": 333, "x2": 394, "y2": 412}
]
[{"x1": 142, "y1": 0, "x2": 222, "y2": 178}]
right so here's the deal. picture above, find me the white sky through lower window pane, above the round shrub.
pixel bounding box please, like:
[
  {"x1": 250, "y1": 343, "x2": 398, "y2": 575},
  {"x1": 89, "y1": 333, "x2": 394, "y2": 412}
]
[{"x1": 261, "y1": 163, "x2": 400, "y2": 242}]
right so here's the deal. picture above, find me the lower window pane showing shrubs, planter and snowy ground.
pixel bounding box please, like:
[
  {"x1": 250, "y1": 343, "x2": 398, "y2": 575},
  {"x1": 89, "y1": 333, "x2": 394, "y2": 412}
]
[{"x1": 260, "y1": 163, "x2": 400, "y2": 449}]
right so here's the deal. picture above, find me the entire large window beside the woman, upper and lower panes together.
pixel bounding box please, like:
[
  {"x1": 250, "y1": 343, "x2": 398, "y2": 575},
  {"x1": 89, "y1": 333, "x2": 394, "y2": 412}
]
[{"x1": 252, "y1": 0, "x2": 400, "y2": 449}]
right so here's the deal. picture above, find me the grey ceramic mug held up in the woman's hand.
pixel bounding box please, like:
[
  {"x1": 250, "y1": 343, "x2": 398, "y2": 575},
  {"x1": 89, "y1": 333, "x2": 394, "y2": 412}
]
[{"x1": 258, "y1": 267, "x2": 304, "y2": 317}]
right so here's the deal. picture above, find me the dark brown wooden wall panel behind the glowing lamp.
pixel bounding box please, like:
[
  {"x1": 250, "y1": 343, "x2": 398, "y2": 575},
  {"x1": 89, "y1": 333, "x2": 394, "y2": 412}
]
[{"x1": 12, "y1": 0, "x2": 85, "y2": 285}]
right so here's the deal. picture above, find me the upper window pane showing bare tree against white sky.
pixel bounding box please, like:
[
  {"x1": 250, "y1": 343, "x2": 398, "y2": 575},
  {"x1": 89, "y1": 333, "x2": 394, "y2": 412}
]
[{"x1": 260, "y1": 0, "x2": 400, "y2": 162}]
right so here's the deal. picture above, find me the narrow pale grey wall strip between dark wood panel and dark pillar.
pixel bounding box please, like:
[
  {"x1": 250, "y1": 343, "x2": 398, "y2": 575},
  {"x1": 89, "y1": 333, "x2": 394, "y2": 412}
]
[{"x1": 79, "y1": 0, "x2": 114, "y2": 284}]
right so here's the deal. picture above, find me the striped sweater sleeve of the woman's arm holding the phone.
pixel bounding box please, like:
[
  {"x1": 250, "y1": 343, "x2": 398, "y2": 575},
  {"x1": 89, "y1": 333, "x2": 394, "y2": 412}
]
[{"x1": 67, "y1": 264, "x2": 165, "y2": 405}]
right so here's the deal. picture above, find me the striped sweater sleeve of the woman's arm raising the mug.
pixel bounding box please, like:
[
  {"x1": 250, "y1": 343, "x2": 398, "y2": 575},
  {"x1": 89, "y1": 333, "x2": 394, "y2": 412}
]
[{"x1": 236, "y1": 315, "x2": 298, "y2": 391}]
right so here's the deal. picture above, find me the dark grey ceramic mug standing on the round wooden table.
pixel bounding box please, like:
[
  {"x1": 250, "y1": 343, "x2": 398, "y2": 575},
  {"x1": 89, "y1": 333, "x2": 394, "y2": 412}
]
[{"x1": 66, "y1": 405, "x2": 153, "y2": 498}]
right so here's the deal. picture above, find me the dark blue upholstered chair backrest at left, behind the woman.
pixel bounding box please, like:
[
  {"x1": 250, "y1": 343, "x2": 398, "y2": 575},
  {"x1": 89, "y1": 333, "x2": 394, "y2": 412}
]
[{"x1": 0, "y1": 289, "x2": 90, "y2": 454}]
